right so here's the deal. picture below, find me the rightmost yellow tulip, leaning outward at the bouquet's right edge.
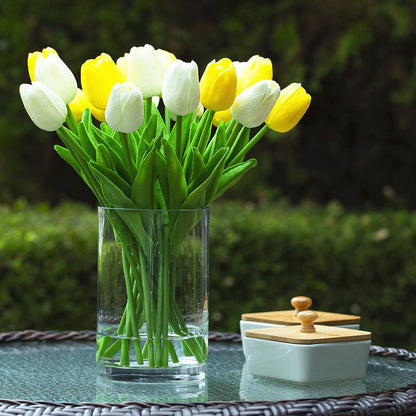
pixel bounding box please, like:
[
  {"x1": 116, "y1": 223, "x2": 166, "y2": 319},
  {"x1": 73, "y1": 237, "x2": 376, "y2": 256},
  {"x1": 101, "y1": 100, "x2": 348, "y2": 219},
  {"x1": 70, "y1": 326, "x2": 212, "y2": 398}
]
[{"x1": 265, "y1": 83, "x2": 311, "y2": 133}]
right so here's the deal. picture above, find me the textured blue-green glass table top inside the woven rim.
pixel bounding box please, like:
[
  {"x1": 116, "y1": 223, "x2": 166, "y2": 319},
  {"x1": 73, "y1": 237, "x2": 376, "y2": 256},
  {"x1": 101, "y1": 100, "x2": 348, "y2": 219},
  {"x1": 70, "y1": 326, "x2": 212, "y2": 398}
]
[{"x1": 0, "y1": 341, "x2": 416, "y2": 403}]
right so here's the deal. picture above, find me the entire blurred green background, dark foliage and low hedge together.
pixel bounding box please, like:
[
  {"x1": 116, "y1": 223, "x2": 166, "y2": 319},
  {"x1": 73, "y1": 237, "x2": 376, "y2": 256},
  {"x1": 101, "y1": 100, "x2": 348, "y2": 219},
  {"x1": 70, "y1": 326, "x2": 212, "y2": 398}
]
[{"x1": 0, "y1": 0, "x2": 416, "y2": 350}]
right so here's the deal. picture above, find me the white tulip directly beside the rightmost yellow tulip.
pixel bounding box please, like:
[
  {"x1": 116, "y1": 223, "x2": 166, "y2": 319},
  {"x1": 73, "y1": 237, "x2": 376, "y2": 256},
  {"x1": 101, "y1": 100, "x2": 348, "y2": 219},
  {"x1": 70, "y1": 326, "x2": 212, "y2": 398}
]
[{"x1": 231, "y1": 80, "x2": 280, "y2": 128}]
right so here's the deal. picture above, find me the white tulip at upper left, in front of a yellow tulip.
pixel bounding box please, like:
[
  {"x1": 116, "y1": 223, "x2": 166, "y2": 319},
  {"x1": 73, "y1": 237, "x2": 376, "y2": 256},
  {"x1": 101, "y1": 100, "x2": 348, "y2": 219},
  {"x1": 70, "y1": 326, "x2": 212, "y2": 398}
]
[{"x1": 35, "y1": 53, "x2": 77, "y2": 104}]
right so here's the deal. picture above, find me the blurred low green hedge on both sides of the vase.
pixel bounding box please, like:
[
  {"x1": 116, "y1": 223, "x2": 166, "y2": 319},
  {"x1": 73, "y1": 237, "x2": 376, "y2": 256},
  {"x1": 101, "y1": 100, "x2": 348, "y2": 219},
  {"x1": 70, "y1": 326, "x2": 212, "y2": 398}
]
[{"x1": 0, "y1": 202, "x2": 416, "y2": 350}]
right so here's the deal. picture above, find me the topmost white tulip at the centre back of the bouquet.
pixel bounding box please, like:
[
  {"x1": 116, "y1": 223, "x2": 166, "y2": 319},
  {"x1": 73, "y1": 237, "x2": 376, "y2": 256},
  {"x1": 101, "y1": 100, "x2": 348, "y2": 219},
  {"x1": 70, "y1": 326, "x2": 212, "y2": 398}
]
[{"x1": 126, "y1": 45, "x2": 165, "y2": 98}]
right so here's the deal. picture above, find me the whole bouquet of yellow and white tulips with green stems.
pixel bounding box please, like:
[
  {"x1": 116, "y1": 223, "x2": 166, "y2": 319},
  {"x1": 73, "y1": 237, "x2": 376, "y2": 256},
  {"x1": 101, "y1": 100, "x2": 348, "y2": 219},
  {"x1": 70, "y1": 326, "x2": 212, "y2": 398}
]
[{"x1": 20, "y1": 45, "x2": 311, "y2": 367}]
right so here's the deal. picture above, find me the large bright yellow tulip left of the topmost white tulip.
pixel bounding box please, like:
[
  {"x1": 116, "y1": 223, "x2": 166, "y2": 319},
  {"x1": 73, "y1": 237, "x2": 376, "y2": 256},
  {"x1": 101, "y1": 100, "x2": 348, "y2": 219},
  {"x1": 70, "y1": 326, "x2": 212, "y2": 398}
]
[{"x1": 81, "y1": 53, "x2": 125, "y2": 110}]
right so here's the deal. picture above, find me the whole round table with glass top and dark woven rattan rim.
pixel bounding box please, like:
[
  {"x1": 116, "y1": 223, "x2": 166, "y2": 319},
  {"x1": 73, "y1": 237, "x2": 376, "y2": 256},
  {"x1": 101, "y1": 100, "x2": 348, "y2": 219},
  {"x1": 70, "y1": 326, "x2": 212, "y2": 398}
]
[{"x1": 0, "y1": 330, "x2": 416, "y2": 416}]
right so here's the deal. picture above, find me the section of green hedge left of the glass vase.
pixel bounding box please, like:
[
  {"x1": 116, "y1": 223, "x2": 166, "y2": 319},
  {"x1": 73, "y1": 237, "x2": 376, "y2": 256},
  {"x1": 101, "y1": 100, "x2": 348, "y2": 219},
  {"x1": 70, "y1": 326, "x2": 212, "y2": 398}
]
[{"x1": 0, "y1": 203, "x2": 97, "y2": 331}]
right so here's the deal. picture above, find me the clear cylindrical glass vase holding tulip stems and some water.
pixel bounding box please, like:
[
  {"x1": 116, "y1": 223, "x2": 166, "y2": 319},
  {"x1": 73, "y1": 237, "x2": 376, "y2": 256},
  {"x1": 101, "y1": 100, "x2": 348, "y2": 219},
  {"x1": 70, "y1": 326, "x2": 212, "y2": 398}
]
[{"x1": 96, "y1": 207, "x2": 209, "y2": 382}]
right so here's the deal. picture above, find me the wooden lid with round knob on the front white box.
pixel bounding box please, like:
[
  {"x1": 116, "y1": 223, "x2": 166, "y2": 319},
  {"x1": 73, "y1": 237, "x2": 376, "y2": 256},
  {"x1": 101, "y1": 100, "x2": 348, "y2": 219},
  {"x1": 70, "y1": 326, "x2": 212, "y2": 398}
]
[{"x1": 244, "y1": 311, "x2": 371, "y2": 344}]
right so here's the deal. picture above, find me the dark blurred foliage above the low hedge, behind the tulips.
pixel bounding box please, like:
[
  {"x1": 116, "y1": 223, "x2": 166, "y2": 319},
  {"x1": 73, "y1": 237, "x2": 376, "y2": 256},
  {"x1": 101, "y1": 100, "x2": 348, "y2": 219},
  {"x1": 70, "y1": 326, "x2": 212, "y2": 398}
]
[{"x1": 0, "y1": 0, "x2": 416, "y2": 208}]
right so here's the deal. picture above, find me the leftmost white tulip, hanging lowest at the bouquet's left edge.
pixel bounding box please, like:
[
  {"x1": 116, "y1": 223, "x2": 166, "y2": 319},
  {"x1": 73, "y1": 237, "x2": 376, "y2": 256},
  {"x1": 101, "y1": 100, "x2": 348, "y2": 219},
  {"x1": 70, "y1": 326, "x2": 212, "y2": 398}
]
[{"x1": 19, "y1": 81, "x2": 68, "y2": 131}]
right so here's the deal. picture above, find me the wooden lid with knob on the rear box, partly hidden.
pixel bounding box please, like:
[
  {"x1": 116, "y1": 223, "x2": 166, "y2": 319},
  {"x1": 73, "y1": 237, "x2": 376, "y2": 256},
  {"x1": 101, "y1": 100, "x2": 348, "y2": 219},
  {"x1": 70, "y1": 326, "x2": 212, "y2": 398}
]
[{"x1": 241, "y1": 296, "x2": 361, "y2": 325}]
